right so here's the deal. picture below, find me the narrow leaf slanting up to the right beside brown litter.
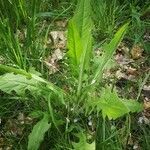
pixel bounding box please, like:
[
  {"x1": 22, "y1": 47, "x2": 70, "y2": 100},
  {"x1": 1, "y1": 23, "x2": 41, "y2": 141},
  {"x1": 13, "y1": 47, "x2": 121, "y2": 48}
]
[{"x1": 91, "y1": 23, "x2": 129, "y2": 84}]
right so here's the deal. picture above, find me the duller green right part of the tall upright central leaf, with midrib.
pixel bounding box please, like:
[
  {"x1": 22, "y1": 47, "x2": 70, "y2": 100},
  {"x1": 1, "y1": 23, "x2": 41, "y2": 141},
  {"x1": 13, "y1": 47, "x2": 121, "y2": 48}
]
[{"x1": 72, "y1": 0, "x2": 93, "y2": 71}]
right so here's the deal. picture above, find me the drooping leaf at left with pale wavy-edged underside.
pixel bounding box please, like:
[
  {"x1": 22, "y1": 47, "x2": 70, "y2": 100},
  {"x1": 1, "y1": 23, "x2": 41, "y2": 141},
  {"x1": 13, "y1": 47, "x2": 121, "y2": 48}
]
[{"x1": 0, "y1": 65, "x2": 65, "y2": 104}]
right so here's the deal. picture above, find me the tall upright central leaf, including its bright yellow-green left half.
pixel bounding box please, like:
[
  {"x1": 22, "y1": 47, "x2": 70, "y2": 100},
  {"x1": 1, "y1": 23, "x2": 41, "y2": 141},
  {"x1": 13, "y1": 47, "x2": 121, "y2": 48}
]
[{"x1": 68, "y1": 0, "x2": 92, "y2": 70}]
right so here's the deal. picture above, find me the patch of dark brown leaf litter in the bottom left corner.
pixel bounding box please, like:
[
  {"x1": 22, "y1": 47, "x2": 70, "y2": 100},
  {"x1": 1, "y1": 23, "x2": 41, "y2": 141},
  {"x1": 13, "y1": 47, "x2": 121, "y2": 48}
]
[{"x1": 0, "y1": 112, "x2": 33, "y2": 150}]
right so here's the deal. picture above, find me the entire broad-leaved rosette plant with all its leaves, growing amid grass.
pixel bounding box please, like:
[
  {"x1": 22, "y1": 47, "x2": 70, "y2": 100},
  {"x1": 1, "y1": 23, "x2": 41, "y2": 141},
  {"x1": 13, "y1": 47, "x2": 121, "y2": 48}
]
[{"x1": 0, "y1": 0, "x2": 142, "y2": 150}]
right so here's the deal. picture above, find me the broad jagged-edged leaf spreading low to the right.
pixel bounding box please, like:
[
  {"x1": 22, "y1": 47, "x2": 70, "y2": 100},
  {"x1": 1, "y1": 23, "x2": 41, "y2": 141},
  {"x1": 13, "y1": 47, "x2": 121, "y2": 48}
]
[{"x1": 87, "y1": 88, "x2": 142, "y2": 119}]
